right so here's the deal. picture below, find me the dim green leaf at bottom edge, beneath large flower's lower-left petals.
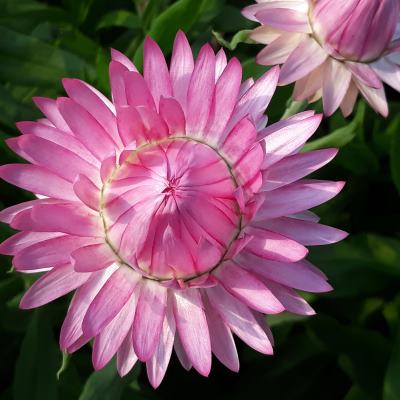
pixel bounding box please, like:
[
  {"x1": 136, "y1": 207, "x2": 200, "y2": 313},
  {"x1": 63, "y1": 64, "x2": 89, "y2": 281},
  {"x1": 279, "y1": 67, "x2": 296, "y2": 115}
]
[{"x1": 79, "y1": 362, "x2": 140, "y2": 400}]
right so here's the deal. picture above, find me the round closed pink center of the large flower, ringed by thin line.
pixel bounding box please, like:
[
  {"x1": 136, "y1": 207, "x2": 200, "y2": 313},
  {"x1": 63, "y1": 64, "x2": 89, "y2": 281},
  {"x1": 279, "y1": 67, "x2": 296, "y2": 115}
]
[{"x1": 101, "y1": 137, "x2": 242, "y2": 280}]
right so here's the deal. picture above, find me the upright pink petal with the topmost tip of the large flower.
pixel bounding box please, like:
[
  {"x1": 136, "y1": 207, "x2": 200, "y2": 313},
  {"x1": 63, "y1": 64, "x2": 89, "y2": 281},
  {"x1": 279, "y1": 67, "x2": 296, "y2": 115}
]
[{"x1": 170, "y1": 31, "x2": 194, "y2": 110}]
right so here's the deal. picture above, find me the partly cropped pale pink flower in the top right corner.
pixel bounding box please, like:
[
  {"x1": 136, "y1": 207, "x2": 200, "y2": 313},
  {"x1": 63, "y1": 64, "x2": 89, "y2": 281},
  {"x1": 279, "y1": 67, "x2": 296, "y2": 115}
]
[{"x1": 243, "y1": 0, "x2": 400, "y2": 116}]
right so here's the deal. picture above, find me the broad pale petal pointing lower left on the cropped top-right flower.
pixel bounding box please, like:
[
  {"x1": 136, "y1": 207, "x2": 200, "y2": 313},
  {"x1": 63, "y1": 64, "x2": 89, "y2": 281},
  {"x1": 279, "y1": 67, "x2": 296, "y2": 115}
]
[{"x1": 279, "y1": 38, "x2": 328, "y2": 85}]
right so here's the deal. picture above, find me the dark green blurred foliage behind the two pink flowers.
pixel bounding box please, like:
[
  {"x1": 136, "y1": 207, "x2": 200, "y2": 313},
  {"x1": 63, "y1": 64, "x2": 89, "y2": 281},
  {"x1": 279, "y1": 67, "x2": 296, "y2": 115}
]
[{"x1": 0, "y1": 0, "x2": 400, "y2": 400}]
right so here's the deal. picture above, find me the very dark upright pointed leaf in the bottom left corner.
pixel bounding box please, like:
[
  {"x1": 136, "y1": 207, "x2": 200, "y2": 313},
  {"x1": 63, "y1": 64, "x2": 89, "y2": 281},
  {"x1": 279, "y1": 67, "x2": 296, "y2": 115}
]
[{"x1": 14, "y1": 310, "x2": 60, "y2": 400}]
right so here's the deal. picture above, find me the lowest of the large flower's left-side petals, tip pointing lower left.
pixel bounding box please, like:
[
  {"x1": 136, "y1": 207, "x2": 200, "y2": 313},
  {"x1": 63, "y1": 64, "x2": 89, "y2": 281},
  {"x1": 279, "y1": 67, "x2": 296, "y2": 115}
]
[{"x1": 19, "y1": 264, "x2": 90, "y2": 310}]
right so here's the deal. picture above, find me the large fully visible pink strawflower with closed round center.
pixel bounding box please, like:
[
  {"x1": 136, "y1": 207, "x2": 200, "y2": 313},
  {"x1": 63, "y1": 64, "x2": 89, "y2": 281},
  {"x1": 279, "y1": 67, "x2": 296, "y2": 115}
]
[{"x1": 0, "y1": 32, "x2": 346, "y2": 387}]
